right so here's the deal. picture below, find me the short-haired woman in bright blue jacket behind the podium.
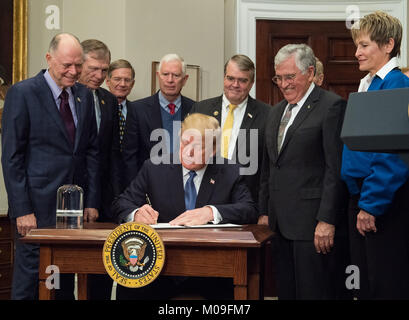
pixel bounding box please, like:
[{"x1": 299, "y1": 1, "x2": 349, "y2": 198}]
[{"x1": 341, "y1": 11, "x2": 409, "y2": 299}]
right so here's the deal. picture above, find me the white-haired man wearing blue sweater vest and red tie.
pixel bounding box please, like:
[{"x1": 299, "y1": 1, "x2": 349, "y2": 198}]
[{"x1": 122, "y1": 54, "x2": 194, "y2": 185}]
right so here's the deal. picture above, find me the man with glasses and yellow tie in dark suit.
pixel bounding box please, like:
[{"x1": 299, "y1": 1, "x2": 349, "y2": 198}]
[{"x1": 191, "y1": 54, "x2": 271, "y2": 202}]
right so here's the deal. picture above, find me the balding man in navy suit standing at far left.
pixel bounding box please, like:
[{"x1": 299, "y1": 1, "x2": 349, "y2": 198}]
[{"x1": 2, "y1": 34, "x2": 99, "y2": 299}]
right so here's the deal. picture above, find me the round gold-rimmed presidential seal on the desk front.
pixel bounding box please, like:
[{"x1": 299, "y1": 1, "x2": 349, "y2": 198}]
[{"x1": 102, "y1": 222, "x2": 165, "y2": 288}]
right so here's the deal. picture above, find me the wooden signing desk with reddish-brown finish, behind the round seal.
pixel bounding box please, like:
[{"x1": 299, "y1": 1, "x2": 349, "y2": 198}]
[{"x1": 21, "y1": 223, "x2": 272, "y2": 300}]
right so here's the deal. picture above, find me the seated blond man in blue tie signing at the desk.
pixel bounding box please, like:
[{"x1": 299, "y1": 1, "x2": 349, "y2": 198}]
[{"x1": 114, "y1": 113, "x2": 257, "y2": 299}]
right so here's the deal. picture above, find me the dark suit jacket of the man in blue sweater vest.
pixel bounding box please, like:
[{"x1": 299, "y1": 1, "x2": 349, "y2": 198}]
[{"x1": 122, "y1": 92, "x2": 194, "y2": 185}]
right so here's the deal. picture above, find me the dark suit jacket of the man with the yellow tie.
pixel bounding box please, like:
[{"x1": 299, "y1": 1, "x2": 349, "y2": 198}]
[{"x1": 190, "y1": 96, "x2": 271, "y2": 203}]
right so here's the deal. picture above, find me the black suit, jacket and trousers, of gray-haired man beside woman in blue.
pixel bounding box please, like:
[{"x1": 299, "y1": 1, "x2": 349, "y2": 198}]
[{"x1": 259, "y1": 86, "x2": 346, "y2": 299}]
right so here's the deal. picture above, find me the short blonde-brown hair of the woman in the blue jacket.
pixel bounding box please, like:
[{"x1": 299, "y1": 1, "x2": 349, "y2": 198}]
[{"x1": 351, "y1": 11, "x2": 402, "y2": 58}]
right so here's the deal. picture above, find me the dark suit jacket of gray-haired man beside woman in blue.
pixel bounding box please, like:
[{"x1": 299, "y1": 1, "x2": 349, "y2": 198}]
[{"x1": 259, "y1": 86, "x2": 346, "y2": 240}]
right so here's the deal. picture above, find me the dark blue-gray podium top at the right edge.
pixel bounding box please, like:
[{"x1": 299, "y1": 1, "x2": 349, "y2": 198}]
[{"x1": 341, "y1": 88, "x2": 409, "y2": 165}]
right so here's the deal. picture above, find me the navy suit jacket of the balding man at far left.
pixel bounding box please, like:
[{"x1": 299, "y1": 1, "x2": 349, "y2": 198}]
[{"x1": 2, "y1": 70, "x2": 99, "y2": 227}]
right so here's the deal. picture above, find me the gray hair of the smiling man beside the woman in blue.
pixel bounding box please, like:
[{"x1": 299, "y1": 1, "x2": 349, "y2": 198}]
[{"x1": 274, "y1": 44, "x2": 316, "y2": 74}]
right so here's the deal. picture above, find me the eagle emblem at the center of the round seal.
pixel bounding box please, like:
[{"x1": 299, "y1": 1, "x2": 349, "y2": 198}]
[{"x1": 120, "y1": 237, "x2": 149, "y2": 272}]
